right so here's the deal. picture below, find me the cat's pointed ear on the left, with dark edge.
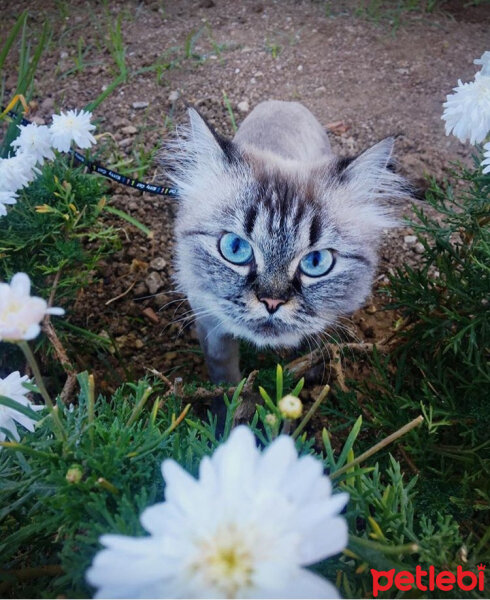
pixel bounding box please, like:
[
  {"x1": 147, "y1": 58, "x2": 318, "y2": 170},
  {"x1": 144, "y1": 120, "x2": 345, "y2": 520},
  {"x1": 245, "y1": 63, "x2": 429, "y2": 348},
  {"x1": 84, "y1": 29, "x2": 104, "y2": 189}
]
[{"x1": 188, "y1": 108, "x2": 237, "y2": 162}]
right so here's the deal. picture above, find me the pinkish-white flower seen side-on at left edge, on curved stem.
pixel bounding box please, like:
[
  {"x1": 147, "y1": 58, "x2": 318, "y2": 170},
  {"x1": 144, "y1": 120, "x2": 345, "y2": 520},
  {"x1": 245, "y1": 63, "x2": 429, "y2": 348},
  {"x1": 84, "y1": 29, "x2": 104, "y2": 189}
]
[{"x1": 0, "y1": 273, "x2": 65, "y2": 342}]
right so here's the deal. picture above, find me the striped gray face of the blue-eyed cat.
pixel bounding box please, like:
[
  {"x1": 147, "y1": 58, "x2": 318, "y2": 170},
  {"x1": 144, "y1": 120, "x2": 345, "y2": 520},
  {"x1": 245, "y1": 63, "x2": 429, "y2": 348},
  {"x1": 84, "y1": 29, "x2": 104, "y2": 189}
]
[{"x1": 167, "y1": 110, "x2": 406, "y2": 346}]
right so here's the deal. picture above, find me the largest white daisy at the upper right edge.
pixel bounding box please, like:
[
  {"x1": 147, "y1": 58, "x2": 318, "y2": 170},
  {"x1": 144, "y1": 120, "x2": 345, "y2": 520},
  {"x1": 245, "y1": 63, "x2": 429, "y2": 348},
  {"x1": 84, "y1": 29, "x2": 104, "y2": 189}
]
[{"x1": 441, "y1": 71, "x2": 490, "y2": 144}]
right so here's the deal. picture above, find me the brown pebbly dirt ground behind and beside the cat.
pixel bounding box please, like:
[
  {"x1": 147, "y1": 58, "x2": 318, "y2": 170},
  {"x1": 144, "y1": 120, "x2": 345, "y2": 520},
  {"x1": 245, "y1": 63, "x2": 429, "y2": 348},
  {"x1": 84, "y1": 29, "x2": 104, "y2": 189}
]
[{"x1": 0, "y1": 0, "x2": 490, "y2": 392}]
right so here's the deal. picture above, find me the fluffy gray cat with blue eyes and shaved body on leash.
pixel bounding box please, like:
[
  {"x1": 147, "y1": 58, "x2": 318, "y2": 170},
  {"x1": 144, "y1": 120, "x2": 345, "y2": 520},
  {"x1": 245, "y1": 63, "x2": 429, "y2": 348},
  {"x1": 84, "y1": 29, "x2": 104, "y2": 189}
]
[{"x1": 169, "y1": 101, "x2": 406, "y2": 383}]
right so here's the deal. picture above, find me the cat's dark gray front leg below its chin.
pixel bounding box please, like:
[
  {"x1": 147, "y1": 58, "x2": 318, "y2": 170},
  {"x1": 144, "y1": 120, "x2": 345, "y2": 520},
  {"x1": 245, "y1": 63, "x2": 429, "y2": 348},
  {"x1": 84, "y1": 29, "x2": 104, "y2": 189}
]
[{"x1": 197, "y1": 317, "x2": 241, "y2": 383}]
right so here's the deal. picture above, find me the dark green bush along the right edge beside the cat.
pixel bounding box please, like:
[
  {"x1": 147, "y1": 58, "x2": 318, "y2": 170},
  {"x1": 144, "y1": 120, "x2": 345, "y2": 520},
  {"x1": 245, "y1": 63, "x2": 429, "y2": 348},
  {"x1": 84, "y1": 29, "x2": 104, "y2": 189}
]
[{"x1": 323, "y1": 157, "x2": 490, "y2": 594}]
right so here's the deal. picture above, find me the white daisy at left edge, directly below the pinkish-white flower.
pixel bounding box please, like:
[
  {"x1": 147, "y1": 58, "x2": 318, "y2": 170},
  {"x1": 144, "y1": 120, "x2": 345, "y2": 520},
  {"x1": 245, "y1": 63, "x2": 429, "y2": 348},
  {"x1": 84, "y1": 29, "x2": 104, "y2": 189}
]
[{"x1": 0, "y1": 371, "x2": 44, "y2": 448}]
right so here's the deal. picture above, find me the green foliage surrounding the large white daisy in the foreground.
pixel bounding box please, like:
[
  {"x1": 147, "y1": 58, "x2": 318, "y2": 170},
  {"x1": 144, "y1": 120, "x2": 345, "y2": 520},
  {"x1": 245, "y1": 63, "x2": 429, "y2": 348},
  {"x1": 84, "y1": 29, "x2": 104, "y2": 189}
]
[{"x1": 0, "y1": 368, "x2": 484, "y2": 597}]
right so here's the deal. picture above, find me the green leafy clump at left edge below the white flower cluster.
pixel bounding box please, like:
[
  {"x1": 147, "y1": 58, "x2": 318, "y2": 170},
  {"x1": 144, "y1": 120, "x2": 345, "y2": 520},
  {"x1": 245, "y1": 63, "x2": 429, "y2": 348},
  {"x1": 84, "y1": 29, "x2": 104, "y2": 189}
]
[{"x1": 0, "y1": 158, "x2": 118, "y2": 299}]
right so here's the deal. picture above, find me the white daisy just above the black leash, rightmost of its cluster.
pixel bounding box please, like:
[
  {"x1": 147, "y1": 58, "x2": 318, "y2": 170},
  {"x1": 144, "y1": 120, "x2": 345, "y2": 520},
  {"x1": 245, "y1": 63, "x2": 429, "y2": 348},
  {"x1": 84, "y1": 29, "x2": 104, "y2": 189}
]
[{"x1": 49, "y1": 110, "x2": 96, "y2": 152}]
